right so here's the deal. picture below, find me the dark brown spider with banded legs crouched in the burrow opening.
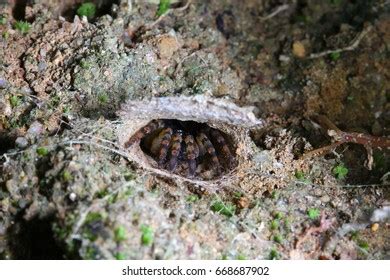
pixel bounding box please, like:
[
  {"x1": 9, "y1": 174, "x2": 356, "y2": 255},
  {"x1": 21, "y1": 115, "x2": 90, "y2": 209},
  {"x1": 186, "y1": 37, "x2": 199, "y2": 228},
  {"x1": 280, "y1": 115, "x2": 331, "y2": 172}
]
[{"x1": 125, "y1": 119, "x2": 235, "y2": 180}]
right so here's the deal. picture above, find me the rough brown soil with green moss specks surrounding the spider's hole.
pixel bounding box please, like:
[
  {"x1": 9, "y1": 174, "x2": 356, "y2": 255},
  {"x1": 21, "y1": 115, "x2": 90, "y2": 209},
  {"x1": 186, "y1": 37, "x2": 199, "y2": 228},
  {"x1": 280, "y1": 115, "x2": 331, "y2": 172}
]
[{"x1": 0, "y1": 0, "x2": 390, "y2": 259}]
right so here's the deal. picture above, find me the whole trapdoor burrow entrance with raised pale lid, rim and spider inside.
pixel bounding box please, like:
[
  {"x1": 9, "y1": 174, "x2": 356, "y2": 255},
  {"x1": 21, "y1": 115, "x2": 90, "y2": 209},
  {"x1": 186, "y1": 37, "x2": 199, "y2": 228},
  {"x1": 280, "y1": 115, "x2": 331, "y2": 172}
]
[{"x1": 118, "y1": 96, "x2": 264, "y2": 185}]
